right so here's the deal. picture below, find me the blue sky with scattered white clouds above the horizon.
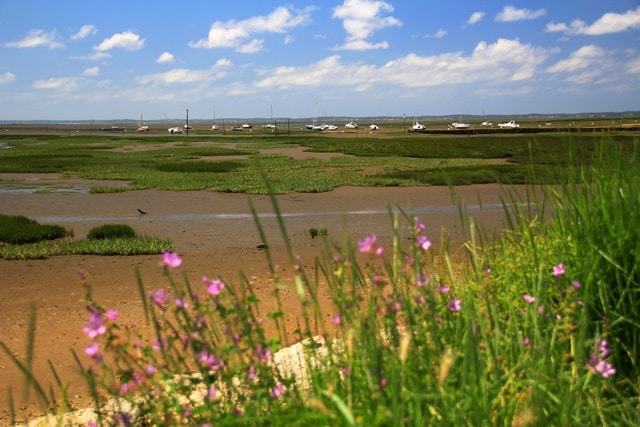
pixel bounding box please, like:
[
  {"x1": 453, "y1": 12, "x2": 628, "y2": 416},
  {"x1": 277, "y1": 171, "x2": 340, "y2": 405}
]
[{"x1": 0, "y1": 0, "x2": 640, "y2": 122}]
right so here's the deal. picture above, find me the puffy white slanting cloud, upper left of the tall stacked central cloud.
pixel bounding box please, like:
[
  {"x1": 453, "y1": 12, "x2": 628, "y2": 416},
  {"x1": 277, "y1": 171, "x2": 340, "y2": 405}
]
[{"x1": 189, "y1": 7, "x2": 313, "y2": 53}]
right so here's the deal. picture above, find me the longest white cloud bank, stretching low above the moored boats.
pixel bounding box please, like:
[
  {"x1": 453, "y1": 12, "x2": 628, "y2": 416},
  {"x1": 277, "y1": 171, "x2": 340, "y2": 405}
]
[{"x1": 254, "y1": 39, "x2": 548, "y2": 89}]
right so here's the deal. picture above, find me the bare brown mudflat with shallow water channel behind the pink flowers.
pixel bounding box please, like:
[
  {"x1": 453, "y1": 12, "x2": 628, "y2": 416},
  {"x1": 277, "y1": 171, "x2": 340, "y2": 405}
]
[{"x1": 0, "y1": 179, "x2": 525, "y2": 425}]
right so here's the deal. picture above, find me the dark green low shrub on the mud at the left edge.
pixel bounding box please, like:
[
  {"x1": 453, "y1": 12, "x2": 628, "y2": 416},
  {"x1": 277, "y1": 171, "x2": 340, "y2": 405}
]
[{"x1": 0, "y1": 215, "x2": 71, "y2": 245}]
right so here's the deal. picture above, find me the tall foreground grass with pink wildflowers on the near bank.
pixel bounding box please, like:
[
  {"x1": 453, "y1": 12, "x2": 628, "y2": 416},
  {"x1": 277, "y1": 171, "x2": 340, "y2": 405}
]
[{"x1": 2, "y1": 134, "x2": 640, "y2": 426}]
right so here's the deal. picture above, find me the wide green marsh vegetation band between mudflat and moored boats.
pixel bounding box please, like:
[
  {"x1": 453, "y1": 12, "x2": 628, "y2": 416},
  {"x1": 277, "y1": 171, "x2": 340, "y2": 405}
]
[{"x1": 0, "y1": 132, "x2": 633, "y2": 194}]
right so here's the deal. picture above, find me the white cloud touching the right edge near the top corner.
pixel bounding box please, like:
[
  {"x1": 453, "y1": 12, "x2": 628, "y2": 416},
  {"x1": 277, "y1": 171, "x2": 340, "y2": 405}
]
[{"x1": 546, "y1": 6, "x2": 640, "y2": 36}]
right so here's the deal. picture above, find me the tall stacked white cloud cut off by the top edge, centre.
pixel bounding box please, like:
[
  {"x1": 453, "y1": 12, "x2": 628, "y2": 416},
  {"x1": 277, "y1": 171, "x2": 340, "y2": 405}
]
[{"x1": 332, "y1": 0, "x2": 402, "y2": 50}]
